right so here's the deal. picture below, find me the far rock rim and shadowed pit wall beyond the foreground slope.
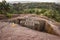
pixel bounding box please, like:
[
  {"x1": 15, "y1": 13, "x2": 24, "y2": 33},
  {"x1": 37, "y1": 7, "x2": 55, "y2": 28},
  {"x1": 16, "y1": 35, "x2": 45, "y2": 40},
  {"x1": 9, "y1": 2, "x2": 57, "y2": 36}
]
[{"x1": 0, "y1": 14, "x2": 60, "y2": 36}]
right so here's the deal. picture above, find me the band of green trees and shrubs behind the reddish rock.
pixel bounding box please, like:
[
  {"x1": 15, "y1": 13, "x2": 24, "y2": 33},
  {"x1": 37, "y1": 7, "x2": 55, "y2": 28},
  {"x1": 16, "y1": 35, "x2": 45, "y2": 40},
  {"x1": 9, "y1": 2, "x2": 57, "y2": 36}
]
[{"x1": 0, "y1": 1, "x2": 60, "y2": 22}]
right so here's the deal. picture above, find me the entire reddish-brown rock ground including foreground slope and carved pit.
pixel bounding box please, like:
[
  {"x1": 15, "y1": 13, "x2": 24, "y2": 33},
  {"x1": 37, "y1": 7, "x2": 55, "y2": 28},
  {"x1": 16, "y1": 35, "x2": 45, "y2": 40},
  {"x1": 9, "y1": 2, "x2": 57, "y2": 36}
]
[{"x1": 0, "y1": 14, "x2": 60, "y2": 40}]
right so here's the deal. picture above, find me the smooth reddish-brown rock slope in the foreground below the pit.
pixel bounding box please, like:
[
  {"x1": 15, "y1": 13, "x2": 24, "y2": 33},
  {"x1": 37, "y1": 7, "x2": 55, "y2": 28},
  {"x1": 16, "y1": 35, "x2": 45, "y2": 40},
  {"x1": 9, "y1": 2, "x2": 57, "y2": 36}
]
[{"x1": 0, "y1": 22, "x2": 60, "y2": 40}]
